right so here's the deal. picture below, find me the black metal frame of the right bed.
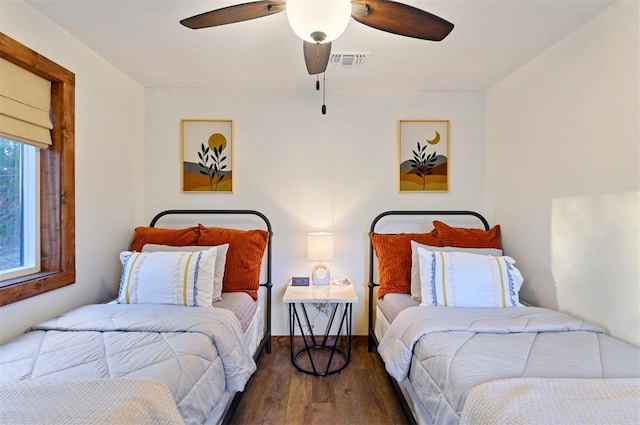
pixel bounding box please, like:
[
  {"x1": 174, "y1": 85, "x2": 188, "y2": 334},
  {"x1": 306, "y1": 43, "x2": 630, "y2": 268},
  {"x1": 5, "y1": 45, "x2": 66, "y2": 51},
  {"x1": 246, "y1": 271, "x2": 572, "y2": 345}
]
[{"x1": 367, "y1": 210, "x2": 489, "y2": 425}]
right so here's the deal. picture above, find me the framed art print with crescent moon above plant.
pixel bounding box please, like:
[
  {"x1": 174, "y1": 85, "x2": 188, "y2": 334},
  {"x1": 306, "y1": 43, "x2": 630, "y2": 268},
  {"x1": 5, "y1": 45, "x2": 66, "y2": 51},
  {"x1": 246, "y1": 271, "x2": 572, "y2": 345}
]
[{"x1": 398, "y1": 120, "x2": 449, "y2": 192}]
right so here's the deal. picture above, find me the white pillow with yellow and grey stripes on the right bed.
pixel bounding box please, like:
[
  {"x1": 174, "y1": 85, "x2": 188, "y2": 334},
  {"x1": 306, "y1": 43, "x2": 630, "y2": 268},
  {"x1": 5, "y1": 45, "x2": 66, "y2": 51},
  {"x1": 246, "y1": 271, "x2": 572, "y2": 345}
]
[{"x1": 418, "y1": 248, "x2": 523, "y2": 307}]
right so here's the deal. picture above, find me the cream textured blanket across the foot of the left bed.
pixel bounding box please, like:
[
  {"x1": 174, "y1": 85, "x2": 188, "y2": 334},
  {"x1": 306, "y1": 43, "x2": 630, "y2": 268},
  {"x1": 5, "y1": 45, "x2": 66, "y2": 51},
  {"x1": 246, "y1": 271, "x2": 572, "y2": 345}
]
[{"x1": 0, "y1": 378, "x2": 184, "y2": 425}]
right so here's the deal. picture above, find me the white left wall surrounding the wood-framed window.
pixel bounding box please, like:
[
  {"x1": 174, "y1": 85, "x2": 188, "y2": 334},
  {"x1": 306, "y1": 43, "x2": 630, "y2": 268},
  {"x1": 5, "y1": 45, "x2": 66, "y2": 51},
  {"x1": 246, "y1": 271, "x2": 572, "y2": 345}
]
[{"x1": 0, "y1": 1, "x2": 145, "y2": 342}]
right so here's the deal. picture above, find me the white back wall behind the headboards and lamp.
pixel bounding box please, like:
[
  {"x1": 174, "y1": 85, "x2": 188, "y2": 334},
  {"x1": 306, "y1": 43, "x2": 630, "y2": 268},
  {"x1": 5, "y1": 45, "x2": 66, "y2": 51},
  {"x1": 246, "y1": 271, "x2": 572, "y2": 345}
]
[{"x1": 144, "y1": 89, "x2": 485, "y2": 335}]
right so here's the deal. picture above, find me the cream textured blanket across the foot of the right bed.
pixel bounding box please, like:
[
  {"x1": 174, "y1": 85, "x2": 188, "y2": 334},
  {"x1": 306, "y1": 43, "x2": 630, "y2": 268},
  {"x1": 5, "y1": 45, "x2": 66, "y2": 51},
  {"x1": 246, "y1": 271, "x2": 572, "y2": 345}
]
[{"x1": 460, "y1": 378, "x2": 640, "y2": 425}]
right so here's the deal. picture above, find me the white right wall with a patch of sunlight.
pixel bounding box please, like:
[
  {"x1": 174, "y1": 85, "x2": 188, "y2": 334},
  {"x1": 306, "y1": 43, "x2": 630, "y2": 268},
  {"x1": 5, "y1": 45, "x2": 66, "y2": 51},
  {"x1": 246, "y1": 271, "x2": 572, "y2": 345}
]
[{"x1": 485, "y1": 0, "x2": 640, "y2": 344}]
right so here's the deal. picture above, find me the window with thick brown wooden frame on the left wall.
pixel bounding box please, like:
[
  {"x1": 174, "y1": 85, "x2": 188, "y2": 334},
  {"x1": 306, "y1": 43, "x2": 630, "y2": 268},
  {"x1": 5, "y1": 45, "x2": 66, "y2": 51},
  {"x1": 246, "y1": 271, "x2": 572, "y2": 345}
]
[{"x1": 0, "y1": 32, "x2": 76, "y2": 306}]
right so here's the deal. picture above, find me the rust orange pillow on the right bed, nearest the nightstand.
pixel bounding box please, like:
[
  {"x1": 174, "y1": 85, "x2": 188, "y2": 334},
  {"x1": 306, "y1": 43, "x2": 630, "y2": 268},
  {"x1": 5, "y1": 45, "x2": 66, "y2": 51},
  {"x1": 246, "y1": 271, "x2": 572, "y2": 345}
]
[{"x1": 370, "y1": 229, "x2": 442, "y2": 298}]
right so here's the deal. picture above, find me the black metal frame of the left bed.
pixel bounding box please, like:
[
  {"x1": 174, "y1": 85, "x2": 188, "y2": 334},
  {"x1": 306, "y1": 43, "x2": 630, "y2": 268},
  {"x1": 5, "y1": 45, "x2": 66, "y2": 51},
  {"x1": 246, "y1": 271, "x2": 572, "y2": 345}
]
[{"x1": 149, "y1": 209, "x2": 273, "y2": 424}]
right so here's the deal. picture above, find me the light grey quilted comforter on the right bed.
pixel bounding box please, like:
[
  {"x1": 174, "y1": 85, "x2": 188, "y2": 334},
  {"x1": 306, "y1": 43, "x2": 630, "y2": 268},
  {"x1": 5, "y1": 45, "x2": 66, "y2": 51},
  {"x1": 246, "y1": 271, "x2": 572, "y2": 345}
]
[{"x1": 378, "y1": 307, "x2": 640, "y2": 424}]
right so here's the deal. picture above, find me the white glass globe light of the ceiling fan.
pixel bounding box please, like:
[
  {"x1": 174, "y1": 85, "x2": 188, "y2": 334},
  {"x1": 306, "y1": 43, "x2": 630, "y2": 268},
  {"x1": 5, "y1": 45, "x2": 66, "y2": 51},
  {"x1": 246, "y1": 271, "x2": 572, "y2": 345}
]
[{"x1": 286, "y1": 0, "x2": 351, "y2": 43}]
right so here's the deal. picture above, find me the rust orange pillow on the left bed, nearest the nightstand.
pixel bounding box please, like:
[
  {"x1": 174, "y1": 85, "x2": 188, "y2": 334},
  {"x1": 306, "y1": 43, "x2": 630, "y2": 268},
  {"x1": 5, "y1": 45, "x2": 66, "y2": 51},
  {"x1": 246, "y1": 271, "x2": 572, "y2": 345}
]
[{"x1": 198, "y1": 224, "x2": 269, "y2": 300}]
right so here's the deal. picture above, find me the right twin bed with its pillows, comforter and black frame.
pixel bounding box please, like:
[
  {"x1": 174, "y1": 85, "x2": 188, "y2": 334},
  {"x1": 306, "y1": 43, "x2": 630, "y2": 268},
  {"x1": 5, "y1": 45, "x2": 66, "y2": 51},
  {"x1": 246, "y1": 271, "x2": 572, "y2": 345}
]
[{"x1": 368, "y1": 211, "x2": 640, "y2": 425}]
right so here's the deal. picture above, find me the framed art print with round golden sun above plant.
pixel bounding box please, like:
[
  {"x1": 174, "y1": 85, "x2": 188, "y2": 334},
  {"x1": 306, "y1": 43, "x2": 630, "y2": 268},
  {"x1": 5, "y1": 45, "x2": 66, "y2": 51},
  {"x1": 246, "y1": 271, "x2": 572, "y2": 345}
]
[{"x1": 180, "y1": 119, "x2": 233, "y2": 193}]
